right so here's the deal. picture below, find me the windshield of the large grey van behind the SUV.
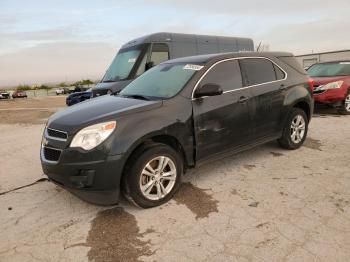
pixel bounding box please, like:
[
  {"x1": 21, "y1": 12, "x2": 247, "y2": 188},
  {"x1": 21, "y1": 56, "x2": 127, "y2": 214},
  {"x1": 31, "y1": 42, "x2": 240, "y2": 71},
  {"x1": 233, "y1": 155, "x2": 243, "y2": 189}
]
[{"x1": 102, "y1": 45, "x2": 146, "y2": 82}]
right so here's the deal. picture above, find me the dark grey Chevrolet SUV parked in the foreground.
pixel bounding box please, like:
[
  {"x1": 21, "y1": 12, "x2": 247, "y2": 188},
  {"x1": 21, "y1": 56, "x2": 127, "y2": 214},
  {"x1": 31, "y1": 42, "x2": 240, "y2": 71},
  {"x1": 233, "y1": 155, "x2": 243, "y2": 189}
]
[{"x1": 41, "y1": 52, "x2": 313, "y2": 208}]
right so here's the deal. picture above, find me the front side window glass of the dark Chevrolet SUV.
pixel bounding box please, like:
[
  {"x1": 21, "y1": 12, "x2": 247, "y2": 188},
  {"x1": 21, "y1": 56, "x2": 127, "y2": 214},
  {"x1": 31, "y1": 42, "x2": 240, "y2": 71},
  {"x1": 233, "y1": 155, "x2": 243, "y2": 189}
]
[{"x1": 201, "y1": 60, "x2": 242, "y2": 92}]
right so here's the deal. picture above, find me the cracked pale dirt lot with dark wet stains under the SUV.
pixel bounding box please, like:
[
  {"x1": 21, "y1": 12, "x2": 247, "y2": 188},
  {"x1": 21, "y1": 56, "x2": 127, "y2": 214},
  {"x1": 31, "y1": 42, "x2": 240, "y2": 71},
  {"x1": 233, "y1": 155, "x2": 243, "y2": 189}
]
[{"x1": 0, "y1": 98, "x2": 350, "y2": 261}]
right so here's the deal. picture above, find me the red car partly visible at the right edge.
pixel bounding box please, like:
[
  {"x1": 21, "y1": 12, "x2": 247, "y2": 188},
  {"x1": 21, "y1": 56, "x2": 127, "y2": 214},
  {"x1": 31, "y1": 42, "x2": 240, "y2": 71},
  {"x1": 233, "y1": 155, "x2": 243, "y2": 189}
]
[{"x1": 308, "y1": 61, "x2": 350, "y2": 115}]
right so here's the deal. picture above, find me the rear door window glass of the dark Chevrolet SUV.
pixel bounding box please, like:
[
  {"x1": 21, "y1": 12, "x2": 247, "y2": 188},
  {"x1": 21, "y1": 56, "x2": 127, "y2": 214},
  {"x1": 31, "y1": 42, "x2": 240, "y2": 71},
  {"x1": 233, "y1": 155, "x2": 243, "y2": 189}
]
[{"x1": 240, "y1": 58, "x2": 276, "y2": 86}]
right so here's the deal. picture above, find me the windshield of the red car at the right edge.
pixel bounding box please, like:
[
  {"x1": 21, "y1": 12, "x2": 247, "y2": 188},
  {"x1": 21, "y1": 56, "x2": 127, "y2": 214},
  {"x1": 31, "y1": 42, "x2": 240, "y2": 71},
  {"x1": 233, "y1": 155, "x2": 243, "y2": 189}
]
[{"x1": 307, "y1": 62, "x2": 350, "y2": 77}]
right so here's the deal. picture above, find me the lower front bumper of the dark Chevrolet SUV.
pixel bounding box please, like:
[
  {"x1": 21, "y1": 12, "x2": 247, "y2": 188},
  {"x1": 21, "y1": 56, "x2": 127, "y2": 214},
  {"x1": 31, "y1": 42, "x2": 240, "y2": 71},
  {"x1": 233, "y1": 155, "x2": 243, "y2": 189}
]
[{"x1": 41, "y1": 149, "x2": 124, "y2": 205}]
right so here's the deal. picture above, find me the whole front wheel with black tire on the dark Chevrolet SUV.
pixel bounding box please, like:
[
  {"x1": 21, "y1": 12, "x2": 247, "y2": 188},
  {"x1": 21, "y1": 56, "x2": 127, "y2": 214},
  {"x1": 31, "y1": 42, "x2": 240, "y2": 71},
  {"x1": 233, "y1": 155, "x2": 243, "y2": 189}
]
[{"x1": 123, "y1": 143, "x2": 183, "y2": 208}]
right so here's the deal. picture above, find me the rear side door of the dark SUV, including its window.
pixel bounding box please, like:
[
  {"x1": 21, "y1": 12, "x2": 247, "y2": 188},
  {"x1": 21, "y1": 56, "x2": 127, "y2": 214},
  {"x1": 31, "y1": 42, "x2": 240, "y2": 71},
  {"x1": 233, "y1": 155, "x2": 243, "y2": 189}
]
[{"x1": 240, "y1": 58, "x2": 285, "y2": 139}]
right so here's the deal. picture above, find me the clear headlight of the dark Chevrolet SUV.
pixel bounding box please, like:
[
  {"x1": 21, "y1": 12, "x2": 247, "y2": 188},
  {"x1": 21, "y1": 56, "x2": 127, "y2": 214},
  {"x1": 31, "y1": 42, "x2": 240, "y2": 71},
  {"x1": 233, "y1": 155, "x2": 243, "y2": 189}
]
[{"x1": 70, "y1": 121, "x2": 117, "y2": 150}]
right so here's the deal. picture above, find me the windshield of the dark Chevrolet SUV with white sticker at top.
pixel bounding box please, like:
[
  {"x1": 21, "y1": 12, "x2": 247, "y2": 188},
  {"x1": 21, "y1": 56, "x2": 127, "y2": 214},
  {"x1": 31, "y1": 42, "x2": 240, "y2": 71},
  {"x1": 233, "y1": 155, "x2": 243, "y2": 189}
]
[{"x1": 119, "y1": 63, "x2": 203, "y2": 99}]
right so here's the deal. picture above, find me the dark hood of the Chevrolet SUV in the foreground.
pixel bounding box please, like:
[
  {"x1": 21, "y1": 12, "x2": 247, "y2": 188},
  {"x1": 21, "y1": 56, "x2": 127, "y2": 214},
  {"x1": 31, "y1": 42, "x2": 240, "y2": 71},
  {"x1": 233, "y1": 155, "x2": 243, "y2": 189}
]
[{"x1": 48, "y1": 95, "x2": 163, "y2": 134}]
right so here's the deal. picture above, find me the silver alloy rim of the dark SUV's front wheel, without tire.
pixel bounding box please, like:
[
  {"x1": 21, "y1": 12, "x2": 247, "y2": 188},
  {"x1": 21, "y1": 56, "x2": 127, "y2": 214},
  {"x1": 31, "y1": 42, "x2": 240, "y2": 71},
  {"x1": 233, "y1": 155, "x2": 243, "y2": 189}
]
[{"x1": 139, "y1": 156, "x2": 177, "y2": 200}]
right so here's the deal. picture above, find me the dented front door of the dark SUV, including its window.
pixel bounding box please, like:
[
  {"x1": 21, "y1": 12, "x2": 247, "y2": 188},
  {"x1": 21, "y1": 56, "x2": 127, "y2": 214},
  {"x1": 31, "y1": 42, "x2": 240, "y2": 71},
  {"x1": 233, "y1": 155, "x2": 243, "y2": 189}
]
[{"x1": 192, "y1": 60, "x2": 251, "y2": 160}]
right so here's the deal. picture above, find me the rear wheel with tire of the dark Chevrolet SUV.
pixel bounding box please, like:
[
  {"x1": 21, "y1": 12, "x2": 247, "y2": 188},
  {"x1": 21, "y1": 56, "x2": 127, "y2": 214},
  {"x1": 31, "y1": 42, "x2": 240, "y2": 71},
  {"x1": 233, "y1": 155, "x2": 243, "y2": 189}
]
[{"x1": 277, "y1": 108, "x2": 309, "y2": 150}]
